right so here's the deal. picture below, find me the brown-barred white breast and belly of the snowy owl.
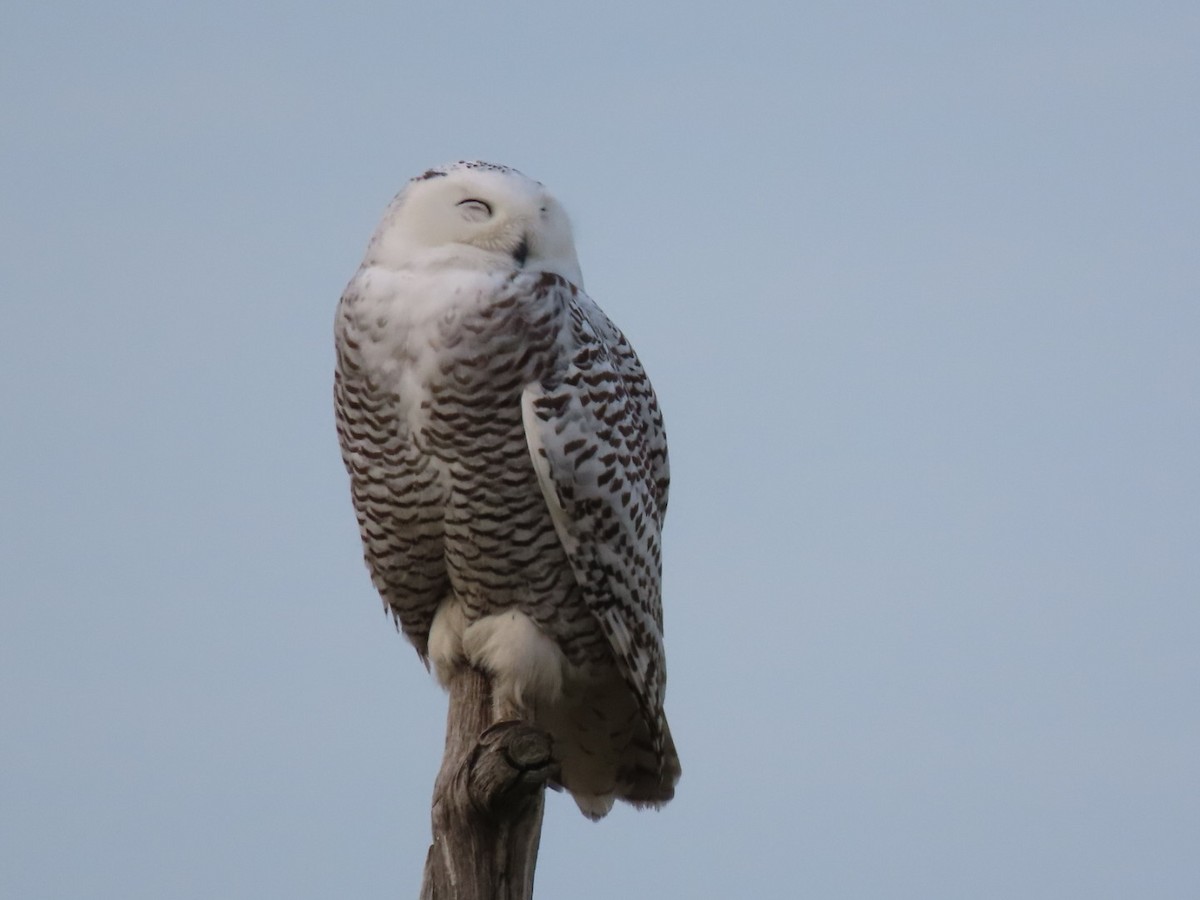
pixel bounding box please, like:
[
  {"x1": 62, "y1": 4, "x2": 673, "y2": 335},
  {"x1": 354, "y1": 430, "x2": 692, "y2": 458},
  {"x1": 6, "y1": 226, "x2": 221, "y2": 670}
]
[{"x1": 337, "y1": 274, "x2": 608, "y2": 665}]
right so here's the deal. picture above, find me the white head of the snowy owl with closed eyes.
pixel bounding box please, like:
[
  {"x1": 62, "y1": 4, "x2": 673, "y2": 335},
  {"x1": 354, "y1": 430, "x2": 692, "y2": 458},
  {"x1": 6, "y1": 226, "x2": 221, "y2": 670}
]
[{"x1": 365, "y1": 162, "x2": 583, "y2": 288}]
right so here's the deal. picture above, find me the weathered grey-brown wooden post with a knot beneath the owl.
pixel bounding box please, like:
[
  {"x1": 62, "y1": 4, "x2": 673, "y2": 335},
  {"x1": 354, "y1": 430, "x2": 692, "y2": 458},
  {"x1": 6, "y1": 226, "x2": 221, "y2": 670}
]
[{"x1": 421, "y1": 666, "x2": 556, "y2": 900}]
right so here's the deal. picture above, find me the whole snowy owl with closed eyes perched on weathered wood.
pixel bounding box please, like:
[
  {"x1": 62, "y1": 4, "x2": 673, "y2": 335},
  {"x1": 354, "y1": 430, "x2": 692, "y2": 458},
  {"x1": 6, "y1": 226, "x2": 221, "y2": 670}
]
[{"x1": 334, "y1": 162, "x2": 679, "y2": 818}]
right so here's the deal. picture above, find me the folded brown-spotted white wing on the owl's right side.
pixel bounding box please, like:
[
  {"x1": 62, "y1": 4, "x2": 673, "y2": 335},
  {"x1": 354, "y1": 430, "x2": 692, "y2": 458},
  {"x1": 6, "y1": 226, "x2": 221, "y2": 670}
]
[{"x1": 522, "y1": 280, "x2": 668, "y2": 760}]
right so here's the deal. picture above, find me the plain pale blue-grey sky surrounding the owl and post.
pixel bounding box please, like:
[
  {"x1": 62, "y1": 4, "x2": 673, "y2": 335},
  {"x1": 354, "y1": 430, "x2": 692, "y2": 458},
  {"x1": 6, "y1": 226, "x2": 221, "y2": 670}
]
[{"x1": 0, "y1": 0, "x2": 1200, "y2": 900}]
